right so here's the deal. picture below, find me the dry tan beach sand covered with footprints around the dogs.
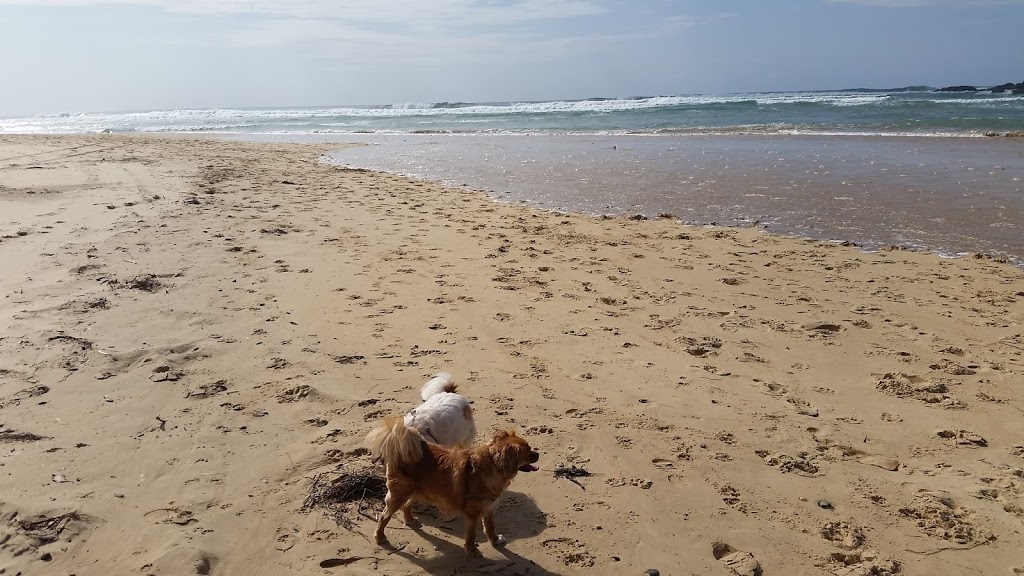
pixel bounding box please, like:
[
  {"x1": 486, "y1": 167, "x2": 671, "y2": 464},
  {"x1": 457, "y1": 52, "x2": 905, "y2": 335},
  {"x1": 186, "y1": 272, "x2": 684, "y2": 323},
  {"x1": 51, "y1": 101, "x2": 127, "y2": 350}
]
[{"x1": 0, "y1": 132, "x2": 1024, "y2": 576}]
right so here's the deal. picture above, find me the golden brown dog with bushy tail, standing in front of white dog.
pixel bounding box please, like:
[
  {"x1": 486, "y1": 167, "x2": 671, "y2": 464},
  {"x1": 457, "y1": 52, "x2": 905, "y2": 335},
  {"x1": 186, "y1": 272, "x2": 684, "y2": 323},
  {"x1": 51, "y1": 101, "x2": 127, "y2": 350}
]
[{"x1": 367, "y1": 417, "x2": 540, "y2": 557}]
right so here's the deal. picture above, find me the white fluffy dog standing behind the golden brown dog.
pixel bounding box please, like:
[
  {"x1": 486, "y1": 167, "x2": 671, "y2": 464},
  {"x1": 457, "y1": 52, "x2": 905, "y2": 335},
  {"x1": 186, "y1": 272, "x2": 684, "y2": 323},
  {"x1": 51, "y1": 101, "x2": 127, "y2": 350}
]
[{"x1": 406, "y1": 372, "x2": 476, "y2": 446}]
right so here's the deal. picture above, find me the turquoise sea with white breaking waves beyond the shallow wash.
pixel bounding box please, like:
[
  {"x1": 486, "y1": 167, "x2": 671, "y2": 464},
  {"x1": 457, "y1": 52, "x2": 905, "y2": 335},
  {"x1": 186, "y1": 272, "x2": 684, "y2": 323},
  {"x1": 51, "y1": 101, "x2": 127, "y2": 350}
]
[{"x1": 6, "y1": 89, "x2": 1024, "y2": 136}]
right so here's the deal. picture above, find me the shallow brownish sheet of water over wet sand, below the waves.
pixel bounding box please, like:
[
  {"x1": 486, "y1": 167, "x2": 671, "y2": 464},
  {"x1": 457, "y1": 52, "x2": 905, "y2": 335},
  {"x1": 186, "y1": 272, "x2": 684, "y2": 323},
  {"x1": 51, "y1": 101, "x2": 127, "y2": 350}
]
[{"x1": 323, "y1": 134, "x2": 1024, "y2": 261}]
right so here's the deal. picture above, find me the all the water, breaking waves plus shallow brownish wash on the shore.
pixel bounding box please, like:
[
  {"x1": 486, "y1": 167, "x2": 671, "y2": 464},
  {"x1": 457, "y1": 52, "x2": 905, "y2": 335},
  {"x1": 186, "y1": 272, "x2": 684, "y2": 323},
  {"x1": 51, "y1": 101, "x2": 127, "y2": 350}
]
[{"x1": 0, "y1": 88, "x2": 1024, "y2": 264}]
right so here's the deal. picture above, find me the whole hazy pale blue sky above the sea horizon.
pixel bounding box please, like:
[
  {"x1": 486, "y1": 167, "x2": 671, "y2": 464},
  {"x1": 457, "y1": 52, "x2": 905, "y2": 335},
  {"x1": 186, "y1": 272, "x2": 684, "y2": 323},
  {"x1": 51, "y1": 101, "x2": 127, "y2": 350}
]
[{"x1": 0, "y1": 0, "x2": 1024, "y2": 116}]
